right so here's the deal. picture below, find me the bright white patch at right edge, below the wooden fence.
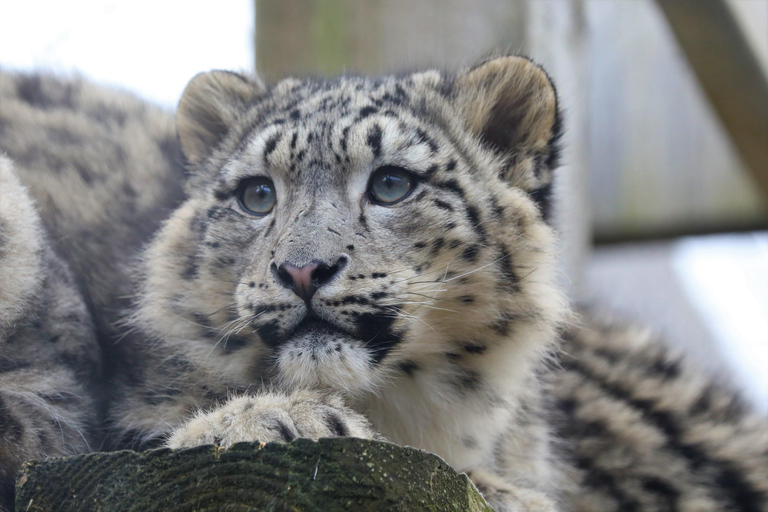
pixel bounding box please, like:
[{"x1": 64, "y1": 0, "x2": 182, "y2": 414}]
[{"x1": 672, "y1": 233, "x2": 768, "y2": 414}]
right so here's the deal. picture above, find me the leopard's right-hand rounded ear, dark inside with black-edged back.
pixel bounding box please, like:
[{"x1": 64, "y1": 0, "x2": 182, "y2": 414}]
[{"x1": 455, "y1": 56, "x2": 561, "y2": 192}]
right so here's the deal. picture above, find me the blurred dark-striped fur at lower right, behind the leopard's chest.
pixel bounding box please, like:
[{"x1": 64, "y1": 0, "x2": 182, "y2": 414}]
[{"x1": 550, "y1": 319, "x2": 768, "y2": 512}]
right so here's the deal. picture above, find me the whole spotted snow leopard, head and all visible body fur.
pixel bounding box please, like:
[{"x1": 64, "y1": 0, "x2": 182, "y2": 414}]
[{"x1": 0, "y1": 55, "x2": 768, "y2": 511}]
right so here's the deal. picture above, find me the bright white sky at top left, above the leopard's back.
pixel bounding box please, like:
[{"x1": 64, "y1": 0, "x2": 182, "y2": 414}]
[{"x1": 0, "y1": 0, "x2": 255, "y2": 107}]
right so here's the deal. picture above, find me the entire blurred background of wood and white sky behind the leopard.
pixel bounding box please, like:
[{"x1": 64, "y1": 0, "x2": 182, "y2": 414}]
[{"x1": 0, "y1": 0, "x2": 768, "y2": 414}]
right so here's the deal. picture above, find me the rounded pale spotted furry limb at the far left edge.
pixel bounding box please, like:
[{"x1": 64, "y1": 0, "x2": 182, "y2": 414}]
[{"x1": 0, "y1": 158, "x2": 101, "y2": 510}]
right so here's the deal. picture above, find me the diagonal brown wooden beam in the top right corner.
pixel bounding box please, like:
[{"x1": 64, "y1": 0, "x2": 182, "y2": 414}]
[{"x1": 657, "y1": 0, "x2": 768, "y2": 195}]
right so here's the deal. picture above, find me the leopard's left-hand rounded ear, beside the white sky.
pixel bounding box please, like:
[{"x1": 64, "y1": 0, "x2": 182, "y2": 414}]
[{"x1": 176, "y1": 71, "x2": 266, "y2": 164}]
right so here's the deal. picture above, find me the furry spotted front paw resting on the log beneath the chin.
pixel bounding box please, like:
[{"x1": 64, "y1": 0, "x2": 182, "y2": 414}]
[{"x1": 166, "y1": 391, "x2": 378, "y2": 448}]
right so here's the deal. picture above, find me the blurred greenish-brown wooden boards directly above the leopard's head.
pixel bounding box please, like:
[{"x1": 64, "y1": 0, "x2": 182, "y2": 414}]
[{"x1": 256, "y1": 0, "x2": 528, "y2": 82}]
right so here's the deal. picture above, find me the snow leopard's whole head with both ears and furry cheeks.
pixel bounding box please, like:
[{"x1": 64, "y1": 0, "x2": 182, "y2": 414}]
[{"x1": 141, "y1": 57, "x2": 563, "y2": 393}]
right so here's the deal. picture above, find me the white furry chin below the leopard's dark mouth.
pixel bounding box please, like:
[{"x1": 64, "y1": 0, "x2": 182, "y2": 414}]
[{"x1": 277, "y1": 332, "x2": 374, "y2": 394}]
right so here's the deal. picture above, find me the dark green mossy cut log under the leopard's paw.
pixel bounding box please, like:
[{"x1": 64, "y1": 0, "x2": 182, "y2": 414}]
[{"x1": 16, "y1": 438, "x2": 491, "y2": 512}]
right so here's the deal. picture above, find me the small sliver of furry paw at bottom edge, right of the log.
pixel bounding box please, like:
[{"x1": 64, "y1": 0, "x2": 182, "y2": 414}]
[{"x1": 467, "y1": 470, "x2": 559, "y2": 512}]
